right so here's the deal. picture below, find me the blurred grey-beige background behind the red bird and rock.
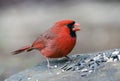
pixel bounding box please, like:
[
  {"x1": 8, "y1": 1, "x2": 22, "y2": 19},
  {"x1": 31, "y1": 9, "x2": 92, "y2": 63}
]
[{"x1": 0, "y1": 0, "x2": 120, "y2": 81}]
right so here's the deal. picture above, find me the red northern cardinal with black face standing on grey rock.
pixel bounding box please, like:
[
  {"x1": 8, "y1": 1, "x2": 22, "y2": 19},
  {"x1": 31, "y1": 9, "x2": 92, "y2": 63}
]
[{"x1": 13, "y1": 20, "x2": 80, "y2": 67}]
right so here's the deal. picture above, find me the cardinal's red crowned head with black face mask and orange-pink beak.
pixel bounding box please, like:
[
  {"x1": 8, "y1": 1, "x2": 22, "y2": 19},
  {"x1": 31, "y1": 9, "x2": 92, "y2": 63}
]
[{"x1": 56, "y1": 20, "x2": 80, "y2": 37}]
